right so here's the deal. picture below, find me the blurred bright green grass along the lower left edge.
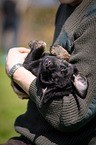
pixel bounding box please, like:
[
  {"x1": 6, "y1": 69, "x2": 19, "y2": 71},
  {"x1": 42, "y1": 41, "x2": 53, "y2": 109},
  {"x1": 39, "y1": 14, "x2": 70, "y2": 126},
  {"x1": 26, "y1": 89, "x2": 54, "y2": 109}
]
[{"x1": 0, "y1": 65, "x2": 27, "y2": 143}]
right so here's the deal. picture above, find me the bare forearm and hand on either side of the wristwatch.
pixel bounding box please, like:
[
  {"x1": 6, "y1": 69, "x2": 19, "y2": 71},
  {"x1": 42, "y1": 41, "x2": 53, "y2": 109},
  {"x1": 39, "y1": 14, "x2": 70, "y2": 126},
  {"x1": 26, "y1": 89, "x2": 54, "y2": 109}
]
[{"x1": 6, "y1": 47, "x2": 36, "y2": 95}]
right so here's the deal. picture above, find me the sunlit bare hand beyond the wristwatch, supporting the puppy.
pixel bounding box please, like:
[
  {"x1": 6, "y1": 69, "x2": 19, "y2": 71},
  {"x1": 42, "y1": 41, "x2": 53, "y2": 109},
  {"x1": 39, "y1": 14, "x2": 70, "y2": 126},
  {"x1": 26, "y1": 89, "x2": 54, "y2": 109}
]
[{"x1": 6, "y1": 47, "x2": 30, "y2": 75}]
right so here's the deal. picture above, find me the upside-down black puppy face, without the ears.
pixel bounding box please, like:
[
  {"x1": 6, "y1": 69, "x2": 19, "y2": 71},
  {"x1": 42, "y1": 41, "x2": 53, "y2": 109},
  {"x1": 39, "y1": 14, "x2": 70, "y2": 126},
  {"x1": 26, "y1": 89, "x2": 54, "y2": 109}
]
[{"x1": 39, "y1": 56, "x2": 75, "y2": 87}]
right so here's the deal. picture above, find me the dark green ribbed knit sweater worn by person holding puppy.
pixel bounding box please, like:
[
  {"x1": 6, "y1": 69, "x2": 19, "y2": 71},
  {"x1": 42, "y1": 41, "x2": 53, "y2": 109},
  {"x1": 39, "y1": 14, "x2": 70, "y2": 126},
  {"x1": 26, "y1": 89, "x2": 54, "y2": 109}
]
[{"x1": 15, "y1": 0, "x2": 96, "y2": 145}]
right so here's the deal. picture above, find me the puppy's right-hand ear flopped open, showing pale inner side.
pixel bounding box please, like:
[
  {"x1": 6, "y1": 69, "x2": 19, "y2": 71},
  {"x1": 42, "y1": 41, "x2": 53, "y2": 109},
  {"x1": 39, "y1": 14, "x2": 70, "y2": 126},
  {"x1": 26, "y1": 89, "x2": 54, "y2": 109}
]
[{"x1": 73, "y1": 72, "x2": 88, "y2": 98}]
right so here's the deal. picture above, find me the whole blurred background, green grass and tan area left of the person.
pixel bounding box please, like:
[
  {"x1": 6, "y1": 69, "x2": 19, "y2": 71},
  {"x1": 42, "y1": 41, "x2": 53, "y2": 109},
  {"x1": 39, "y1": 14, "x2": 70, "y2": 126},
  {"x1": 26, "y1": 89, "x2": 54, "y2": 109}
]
[{"x1": 0, "y1": 0, "x2": 59, "y2": 144}]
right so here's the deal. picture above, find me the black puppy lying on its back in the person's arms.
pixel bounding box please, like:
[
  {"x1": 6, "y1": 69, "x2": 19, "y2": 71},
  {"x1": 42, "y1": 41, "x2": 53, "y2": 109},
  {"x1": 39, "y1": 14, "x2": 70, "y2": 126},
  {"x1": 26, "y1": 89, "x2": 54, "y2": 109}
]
[{"x1": 13, "y1": 41, "x2": 88, "y2": 107}]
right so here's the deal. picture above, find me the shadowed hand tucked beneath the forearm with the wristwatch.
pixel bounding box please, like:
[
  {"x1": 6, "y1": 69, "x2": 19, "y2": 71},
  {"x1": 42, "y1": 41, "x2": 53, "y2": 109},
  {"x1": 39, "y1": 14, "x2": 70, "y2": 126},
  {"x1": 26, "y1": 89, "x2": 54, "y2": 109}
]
[{"x1": 11, "y1": 80, "x2": 29, "y2": 99}]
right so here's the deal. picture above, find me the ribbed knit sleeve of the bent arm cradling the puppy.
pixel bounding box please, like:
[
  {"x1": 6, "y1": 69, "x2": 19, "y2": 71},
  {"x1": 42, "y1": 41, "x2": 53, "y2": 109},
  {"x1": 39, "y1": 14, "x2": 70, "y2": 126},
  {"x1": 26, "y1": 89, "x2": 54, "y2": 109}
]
[{"x1": 29, "y1": 18, "x2": 96, "y2": 132}]
